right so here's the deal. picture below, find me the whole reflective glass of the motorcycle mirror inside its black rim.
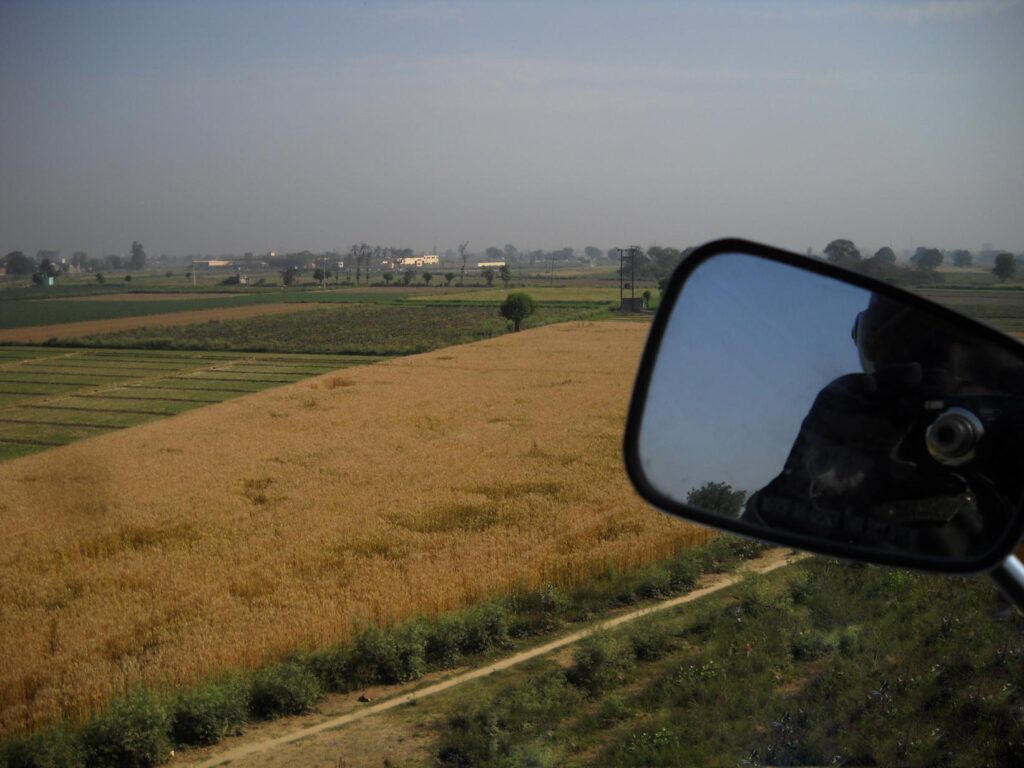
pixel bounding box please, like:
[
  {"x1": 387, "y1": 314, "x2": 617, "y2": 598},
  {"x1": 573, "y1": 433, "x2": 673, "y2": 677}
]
[{"x1": 638, "y1": 254, "x2": 1024, "y2": 561}]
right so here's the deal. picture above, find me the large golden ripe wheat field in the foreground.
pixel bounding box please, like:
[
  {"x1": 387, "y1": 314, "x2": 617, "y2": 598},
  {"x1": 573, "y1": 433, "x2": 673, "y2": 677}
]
[{"x1": 0, "y1": 323, "x2": 708, "y2": 734}]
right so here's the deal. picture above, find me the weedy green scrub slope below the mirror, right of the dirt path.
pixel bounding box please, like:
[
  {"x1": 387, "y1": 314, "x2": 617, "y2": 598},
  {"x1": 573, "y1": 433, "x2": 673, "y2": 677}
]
[{"x1": 420, "y1": 559, "x2": 1024, "y2": 767}]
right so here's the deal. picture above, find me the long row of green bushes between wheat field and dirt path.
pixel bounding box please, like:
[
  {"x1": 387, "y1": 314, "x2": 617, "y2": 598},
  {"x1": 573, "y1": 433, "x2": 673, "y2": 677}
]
[{"x1": 0, "y1": 538, "x2": 761, "y2": 768}]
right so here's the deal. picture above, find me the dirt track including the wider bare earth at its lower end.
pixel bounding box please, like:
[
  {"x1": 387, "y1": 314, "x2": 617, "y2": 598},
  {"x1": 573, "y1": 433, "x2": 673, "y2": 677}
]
[{"x1": 184, "y1": 549, "x2": 804, "y2": 768}]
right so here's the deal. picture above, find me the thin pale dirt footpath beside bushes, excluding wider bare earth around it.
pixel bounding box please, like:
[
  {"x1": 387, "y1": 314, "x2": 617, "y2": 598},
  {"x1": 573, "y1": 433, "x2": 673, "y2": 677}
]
[{"x1": 185, "y1": 549, "x2": 804, "y2": 768}]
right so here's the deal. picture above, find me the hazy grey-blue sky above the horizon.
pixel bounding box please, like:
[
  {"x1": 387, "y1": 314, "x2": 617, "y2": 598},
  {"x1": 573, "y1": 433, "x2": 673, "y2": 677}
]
[{"x1": 0, "y1": 0, "x2": 1024, "y2": 255}]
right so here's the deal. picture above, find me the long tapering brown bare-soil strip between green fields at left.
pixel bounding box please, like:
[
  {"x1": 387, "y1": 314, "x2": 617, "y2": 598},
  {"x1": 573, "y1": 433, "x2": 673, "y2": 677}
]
[{"x1": 0, "y1": 302, "x2": 322, "y2": 344}]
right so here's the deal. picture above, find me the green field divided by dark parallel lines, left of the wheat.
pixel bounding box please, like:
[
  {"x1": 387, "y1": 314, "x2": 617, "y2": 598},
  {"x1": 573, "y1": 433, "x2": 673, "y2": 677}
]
[{"x1": 0, "y1": 347, "x2": 384, "y2": 461}]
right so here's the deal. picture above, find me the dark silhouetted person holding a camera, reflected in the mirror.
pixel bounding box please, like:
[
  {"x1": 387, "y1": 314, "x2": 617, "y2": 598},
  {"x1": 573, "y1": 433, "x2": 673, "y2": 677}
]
[{"x1": 742, "y1": 294, "x2": 1024, "y2": 557}]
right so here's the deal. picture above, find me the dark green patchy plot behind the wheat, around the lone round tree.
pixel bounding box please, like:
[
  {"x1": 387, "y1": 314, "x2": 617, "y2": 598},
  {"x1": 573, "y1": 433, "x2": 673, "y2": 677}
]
[{"x1": 56, "y1": 304, "x2": 592, "y2": 355}]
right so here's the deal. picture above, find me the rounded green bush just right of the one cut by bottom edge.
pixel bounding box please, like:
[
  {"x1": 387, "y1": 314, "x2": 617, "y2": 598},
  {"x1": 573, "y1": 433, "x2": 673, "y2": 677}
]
[{"x1": 171, "y1": 677, "x2": 249, "y2": 744}]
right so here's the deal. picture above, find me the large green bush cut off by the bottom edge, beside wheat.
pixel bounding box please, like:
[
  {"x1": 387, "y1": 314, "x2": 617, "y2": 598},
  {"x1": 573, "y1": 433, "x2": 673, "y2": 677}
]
[{"x1": 82, "y1": 688, "x2": 171, "y2": 768}]
